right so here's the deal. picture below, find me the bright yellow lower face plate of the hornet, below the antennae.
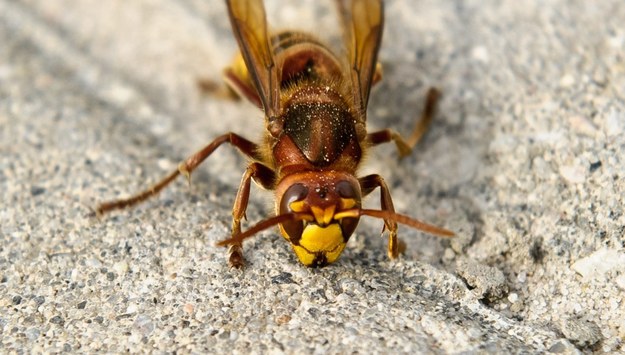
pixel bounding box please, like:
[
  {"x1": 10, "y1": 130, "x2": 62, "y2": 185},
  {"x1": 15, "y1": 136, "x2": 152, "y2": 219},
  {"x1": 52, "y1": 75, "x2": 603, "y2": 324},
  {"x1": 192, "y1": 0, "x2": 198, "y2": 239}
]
[{"x1": 293, "y1": 223, "x2": 345, "y2": 265}]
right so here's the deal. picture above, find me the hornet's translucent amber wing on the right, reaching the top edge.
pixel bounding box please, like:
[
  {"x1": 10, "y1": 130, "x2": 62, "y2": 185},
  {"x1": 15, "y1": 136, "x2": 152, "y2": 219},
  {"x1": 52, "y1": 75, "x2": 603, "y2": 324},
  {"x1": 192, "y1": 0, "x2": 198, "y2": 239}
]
[{"x1": 337, "y1": 0, "x2": 384, "y2": 117}]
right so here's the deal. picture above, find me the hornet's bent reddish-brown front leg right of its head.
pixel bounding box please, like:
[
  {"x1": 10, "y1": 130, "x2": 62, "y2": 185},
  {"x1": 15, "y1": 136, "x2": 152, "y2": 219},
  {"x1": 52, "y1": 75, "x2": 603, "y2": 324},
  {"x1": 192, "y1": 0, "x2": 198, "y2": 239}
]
[{"x1": 358, "y1": 174, "x2": 406, "y2": 259}]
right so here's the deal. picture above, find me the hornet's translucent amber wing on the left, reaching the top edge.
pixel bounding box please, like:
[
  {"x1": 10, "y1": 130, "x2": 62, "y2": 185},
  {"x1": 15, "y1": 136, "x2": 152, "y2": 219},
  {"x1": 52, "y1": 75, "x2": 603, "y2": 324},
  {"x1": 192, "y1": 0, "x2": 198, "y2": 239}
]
[{"x1": 226, "y1": 0, "x2": 280, "y2": 118}]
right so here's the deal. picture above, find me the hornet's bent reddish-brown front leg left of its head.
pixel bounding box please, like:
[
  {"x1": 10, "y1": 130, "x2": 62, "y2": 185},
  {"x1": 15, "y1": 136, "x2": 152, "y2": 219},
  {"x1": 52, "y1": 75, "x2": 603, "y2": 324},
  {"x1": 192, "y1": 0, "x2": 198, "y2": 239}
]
[{"x1": 228, "y1": 162, "x2": 275, "y2": 269}]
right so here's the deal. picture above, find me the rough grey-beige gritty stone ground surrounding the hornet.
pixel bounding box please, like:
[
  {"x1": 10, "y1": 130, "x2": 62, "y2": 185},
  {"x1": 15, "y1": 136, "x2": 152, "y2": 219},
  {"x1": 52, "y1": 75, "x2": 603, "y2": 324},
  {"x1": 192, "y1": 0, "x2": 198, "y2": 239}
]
[{"x1": 0, "y1": 0, "x2": 625, "y2": 353}]
